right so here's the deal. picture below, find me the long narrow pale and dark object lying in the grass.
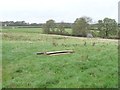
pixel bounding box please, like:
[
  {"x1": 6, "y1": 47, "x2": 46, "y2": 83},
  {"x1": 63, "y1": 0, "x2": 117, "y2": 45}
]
[{"x1": 36, "y1": 50, "x2": 74, "y2": 56}]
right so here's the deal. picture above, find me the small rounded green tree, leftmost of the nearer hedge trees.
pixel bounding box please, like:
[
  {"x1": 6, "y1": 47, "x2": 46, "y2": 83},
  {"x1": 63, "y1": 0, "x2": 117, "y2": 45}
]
[{"x1": 43, "y1": 19, "x2": 56, "y2": 34}]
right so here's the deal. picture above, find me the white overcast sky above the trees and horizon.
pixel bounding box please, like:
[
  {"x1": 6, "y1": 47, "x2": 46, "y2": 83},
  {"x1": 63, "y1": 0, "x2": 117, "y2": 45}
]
[{"x1": 0, "y1": 0, "x2": 119, "y2": 23}]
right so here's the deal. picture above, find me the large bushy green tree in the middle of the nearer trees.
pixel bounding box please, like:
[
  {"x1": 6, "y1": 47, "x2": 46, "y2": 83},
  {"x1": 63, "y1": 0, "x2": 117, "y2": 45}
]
[{"x1": 72, "y1": 17, "x2": 92, "y2": 36}]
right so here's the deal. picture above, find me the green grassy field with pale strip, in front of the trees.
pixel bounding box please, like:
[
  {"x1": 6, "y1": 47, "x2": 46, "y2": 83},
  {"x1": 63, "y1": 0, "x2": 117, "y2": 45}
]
[{"x1": 2, "y1": 28, "x2": 118, "y2": 88}]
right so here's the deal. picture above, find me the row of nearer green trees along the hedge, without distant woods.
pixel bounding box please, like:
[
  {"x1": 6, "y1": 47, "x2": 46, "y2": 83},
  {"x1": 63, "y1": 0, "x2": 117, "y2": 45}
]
[{"x1": 43, "y1": 17, "x2": 120, "y2": 39}]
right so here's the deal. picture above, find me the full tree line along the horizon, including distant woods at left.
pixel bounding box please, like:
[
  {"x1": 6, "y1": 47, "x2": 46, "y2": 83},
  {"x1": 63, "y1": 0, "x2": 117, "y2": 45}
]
[{"x1": 2, "y1": 16, "x2": 120, "y2": 38}]
